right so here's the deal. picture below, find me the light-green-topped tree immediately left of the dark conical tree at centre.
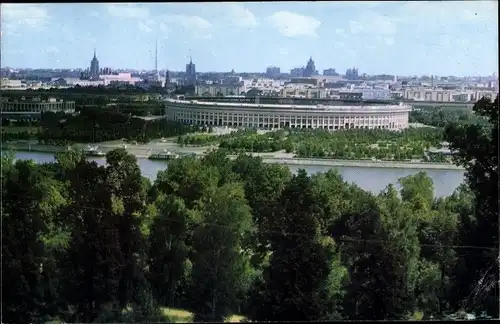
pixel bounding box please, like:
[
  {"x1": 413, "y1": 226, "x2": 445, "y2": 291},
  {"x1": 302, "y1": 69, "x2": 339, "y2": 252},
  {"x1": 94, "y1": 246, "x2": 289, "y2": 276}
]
[{"x1": 190, "y1": 183, "x2": 252, "y2": 321}]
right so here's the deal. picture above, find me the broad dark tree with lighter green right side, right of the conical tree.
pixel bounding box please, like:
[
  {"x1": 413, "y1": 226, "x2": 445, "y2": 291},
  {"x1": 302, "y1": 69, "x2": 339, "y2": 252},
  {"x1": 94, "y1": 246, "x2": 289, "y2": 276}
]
[{"x1": 332, "y1": 186, "x2": 418, "y2": 320}]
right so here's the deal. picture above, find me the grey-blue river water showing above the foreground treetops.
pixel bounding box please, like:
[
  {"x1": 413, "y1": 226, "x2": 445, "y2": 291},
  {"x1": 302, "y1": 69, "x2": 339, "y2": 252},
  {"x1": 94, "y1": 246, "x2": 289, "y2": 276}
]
[{"x1": 5, "y1": 152, "x2": 464, "y2": 197}]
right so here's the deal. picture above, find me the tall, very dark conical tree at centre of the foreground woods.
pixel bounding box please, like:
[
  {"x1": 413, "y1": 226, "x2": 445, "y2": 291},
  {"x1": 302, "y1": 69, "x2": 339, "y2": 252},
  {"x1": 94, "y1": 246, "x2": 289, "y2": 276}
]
[{"x1": 253, "y1": 170, "x2": 344, "y2": 321}]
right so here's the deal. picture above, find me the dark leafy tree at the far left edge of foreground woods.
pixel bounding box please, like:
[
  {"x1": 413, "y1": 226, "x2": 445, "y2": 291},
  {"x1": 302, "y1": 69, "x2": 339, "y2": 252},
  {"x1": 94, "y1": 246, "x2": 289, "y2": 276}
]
[{"x1": 1, "y1": 161, "x2": 67, "y2": 323}]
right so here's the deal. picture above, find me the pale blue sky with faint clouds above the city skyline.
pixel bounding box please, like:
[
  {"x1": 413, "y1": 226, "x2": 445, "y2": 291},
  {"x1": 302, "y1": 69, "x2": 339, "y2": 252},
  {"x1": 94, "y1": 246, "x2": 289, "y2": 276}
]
[{"x1": 0, "y1": 1, "x2": 498, "y2": 76}]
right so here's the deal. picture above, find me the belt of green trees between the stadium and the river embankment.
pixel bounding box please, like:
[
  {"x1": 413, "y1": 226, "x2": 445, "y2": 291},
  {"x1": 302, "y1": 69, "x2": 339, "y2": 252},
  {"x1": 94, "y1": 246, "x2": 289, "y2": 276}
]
[{"x1": 220, "y1": 128, "x2": 442, "y2": 161}]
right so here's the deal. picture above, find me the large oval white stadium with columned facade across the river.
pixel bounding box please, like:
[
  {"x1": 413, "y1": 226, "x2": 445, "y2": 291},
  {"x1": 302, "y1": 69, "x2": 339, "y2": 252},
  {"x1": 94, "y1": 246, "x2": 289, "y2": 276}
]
[{"x1": 164, "y1": 98, "x2": 411, "y2": 130}]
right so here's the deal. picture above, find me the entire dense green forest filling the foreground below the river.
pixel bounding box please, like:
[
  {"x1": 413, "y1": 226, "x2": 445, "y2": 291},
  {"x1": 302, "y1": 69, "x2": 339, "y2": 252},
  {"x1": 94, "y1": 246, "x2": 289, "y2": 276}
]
[{"x1": 1, "y1": 98, "x2": 498, "y2": 323}]
